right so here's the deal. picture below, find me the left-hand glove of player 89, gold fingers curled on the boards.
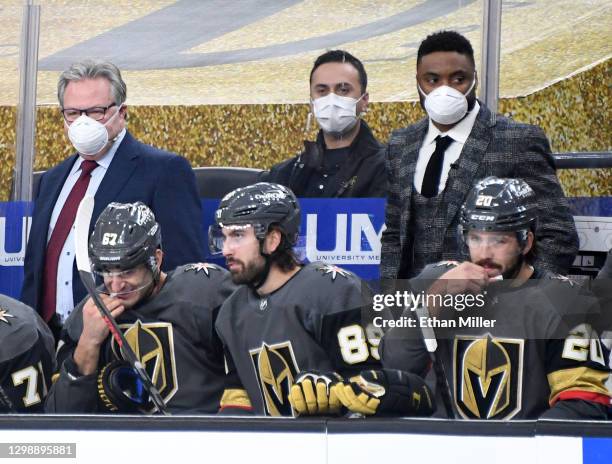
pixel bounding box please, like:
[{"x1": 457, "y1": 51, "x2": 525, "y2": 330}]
[{"x1": 289, "y1": 371, "x2": 342, "y2": 416}]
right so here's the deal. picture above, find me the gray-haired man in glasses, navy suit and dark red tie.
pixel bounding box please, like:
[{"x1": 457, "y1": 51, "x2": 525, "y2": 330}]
[{"x1": 21, "y1": 60, "x2": 204, "y2": 332}]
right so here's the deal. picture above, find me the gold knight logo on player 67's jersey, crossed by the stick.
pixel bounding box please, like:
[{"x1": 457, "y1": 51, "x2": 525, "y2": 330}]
[{"x1": 111, "y1": 320, "x2": 178, "y2": 410}]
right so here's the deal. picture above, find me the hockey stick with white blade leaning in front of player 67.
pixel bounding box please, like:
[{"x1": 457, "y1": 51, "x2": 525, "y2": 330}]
[{"x1": 74, "y1": 196, "x2": 170, "y2": 415}]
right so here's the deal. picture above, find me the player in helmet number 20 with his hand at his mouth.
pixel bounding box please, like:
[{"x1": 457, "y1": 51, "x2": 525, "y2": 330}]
[{"x1": 381, "y1": 177, "x2": 610, "y2": 419}]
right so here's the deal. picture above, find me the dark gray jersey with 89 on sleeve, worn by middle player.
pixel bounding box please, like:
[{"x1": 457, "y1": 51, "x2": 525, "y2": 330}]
[{"x1": 216, "y1": 262, "x2": 380, "y2": 416}]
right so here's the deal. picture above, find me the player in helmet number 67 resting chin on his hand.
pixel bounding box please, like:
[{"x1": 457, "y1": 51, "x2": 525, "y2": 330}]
[{"x1": 46, "y1": 202, "x2": 234, "y2": 413}]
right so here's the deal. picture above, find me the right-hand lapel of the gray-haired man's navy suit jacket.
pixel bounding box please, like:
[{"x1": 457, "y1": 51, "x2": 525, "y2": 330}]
[{"x1": 89, "y1": 132, "x2": 140, "y2": 231}]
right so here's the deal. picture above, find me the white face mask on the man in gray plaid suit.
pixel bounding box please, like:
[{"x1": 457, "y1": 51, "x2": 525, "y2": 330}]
[{"x1": 417, "y1": 74, "x2": 476, "y2": 125}]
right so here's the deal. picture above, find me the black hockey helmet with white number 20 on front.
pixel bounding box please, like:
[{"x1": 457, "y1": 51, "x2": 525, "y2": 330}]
[{"x1": 459, "y1": 177, "x2": 537, "y2": 242}]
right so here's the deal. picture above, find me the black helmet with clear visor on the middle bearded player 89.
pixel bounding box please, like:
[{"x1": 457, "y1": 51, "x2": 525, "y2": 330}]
[{"x1": 208, "y1": 182, "x2": 301, "y2": 253}]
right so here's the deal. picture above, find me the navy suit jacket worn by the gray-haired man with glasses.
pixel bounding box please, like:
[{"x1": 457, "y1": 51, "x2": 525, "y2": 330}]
[{"x1": 21, "y1": 132, "x2": 204, "y2": 312}]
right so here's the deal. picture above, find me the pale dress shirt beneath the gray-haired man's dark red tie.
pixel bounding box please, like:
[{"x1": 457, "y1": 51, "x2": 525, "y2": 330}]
[{"x1": 47, "y1": 129, "x2": 125, "y2": 322}]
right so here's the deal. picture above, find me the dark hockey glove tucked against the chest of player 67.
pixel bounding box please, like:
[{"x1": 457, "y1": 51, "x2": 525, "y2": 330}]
[{"x1": 98, "y1": 361, "x2": 153, "y2": 413}]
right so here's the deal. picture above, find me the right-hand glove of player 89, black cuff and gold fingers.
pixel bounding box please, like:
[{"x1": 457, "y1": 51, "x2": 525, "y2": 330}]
[{"x1": 334, "y1": 369, "x2": 436, "y2": 416}]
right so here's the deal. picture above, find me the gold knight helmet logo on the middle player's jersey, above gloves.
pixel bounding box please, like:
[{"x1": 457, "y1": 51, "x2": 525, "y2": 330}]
[{"x1": 250, "y1": 341, "x2": 299, "y2": 416}]
